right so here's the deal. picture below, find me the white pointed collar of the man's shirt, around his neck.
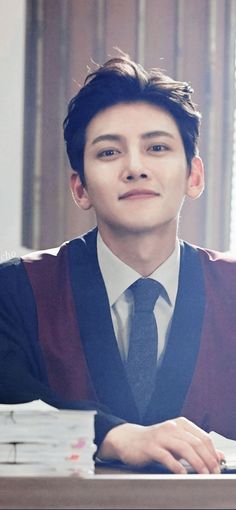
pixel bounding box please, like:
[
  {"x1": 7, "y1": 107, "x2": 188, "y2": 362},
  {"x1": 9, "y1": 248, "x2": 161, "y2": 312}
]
[{"x1": 97, "y1": 232, "x2": 180, "y2": 306}]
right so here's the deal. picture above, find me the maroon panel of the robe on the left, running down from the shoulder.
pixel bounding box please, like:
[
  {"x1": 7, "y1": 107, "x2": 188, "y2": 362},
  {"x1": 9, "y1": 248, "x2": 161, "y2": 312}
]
[{"x1": 23, "y1": 244, "x2": 97, "y2": 401}]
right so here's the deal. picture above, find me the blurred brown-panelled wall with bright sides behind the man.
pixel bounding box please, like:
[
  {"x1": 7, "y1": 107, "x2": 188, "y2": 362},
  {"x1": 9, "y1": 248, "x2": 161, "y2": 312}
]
[{"x1": 0, "y1": 0, "x2": 236, "y2": 261}]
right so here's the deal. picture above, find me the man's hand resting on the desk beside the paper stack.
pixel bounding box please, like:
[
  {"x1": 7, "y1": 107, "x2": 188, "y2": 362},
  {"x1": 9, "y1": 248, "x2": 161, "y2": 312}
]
[{"x1": 98, "y1": 418, "x2": 224, "y2": 474}]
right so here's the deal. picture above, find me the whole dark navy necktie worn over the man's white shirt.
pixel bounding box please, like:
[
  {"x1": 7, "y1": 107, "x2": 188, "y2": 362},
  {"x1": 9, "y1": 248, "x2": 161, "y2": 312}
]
[{"x1": 126, "y1": 278, "x2": 162, "y2": 417}]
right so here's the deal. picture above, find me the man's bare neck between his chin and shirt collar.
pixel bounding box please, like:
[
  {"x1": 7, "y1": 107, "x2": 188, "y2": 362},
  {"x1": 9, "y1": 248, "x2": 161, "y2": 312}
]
[{"x1": 97, "y1": 225, "x2": 176, "y2": 276}]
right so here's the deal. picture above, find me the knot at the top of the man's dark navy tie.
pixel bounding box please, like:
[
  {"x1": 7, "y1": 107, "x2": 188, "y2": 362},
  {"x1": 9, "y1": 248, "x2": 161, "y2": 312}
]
[{"x1": 130, "y1": 278, "x2": 162, "y2": 312}]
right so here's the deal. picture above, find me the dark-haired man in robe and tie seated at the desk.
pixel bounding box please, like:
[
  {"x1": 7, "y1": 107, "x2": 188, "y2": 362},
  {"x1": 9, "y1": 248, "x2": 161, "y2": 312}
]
[{"x1": 0, "y1": 58, "x2": 236, "y2": 473}]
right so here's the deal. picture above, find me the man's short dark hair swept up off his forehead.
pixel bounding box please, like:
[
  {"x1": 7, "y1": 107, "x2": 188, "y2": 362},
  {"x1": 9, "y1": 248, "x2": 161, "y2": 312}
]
[{"x1": 64, "y1": 58, "x2": 200, "y2": 184}]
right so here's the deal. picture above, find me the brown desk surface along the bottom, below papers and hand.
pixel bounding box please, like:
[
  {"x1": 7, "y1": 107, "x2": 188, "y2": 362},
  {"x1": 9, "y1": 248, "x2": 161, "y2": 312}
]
[{"x1": 0, "y1": 470, "x2": 236, "y2": 510}]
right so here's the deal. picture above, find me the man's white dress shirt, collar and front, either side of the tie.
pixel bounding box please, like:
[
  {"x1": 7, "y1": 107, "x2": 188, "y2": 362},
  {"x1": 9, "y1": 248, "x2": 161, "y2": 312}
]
[{"x1": 97, "y1": 233, "x2": 180, "y2": 366}]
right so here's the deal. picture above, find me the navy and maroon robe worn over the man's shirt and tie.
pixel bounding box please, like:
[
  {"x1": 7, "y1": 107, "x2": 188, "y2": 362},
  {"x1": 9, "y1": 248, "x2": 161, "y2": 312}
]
[{"x1": 0, "y1": 229, "x2": 236, "y2": 445}]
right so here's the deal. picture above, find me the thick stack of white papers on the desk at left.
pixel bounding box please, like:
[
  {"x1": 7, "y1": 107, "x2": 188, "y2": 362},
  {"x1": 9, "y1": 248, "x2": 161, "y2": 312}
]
[{"x1": 0, "y1": 400, "x2": 96, "y2": 476}]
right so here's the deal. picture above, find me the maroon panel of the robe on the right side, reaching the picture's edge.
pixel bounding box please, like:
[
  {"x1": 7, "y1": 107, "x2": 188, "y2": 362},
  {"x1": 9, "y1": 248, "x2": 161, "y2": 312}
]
[{"x1": 182, "y1": 250, "x2": 236, "y2": 439}]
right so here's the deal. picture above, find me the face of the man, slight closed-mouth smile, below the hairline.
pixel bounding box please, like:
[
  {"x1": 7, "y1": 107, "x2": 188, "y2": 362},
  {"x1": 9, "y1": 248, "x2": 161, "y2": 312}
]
[{"x1": 73, "y1": 102, "x2": 203, "y2": 240}]
